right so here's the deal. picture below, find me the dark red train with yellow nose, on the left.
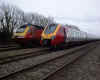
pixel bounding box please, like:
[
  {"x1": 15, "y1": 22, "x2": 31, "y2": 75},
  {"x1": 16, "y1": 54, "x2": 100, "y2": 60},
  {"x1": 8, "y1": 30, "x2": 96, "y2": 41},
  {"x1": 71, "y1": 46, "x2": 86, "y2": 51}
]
[{"x1": 13, "y1": 24, "x2": 44, "y2": 46}]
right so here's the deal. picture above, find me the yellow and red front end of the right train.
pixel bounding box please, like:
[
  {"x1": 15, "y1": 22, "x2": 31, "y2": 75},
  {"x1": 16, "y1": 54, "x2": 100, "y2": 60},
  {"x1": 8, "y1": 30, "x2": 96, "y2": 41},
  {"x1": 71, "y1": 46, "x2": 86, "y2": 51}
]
[{"x1": 40, "y1": 24, "x2": 64, "y2": 47}]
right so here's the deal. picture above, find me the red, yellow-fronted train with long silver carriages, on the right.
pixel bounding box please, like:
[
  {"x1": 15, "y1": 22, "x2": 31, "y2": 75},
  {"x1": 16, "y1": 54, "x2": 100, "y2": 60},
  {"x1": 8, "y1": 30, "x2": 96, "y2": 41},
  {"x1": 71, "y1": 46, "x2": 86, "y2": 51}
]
[{"x1": 40, "y1": 24, "x2": 96, "y2": 47}]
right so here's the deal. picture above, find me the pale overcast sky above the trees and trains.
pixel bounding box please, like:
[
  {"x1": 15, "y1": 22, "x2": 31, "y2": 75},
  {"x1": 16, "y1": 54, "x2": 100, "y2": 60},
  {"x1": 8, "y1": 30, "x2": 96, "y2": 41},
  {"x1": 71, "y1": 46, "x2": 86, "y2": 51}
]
[{"x1": 2, "y1": 0, "x2": 100, "y2": 36}]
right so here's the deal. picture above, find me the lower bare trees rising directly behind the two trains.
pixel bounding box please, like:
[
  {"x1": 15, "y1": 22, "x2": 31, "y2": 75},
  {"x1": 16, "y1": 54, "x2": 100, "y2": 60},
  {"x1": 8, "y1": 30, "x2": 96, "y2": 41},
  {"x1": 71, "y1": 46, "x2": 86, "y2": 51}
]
[{"x1": 22, "y1": 13, "x2": 54, "y2": 26}]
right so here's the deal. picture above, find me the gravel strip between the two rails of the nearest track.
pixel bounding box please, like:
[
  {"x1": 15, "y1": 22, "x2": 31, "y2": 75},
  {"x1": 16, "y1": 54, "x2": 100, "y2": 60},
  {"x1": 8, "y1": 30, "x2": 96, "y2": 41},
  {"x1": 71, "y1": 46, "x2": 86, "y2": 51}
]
[{"x1": 1, "y1": 42, "x2": 94, "y2": 80}]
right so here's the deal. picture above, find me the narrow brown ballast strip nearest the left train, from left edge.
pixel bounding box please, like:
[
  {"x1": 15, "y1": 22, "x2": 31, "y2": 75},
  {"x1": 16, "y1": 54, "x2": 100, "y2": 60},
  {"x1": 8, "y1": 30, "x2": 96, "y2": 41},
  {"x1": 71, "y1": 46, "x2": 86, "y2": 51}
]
[{"x1": 0, "y1": 47, "x2": 43, "y2": 60}]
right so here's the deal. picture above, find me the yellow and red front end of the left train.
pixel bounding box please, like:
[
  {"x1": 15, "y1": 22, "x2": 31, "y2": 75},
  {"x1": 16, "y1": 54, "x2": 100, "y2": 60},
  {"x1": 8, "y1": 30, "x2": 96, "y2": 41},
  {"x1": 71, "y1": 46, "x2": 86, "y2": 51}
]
[{"x1": 13, "y1": 25, "x2": 32, "y2": 44}]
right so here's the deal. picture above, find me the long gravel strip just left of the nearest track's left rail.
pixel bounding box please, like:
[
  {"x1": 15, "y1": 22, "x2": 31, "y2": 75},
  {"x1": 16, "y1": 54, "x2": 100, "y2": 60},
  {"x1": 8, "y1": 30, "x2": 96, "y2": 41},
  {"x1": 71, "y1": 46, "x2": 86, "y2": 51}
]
[{"x1": 0, "y1": 44, "x2": 92, "y2": 77}]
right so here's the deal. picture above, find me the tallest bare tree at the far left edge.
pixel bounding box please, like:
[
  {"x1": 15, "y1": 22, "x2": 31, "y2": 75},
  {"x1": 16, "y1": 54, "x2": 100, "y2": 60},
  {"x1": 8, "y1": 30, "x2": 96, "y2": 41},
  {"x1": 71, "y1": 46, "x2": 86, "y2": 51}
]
[{"x1": 0, "y1": 4, "x2": 24, "y2": 38}]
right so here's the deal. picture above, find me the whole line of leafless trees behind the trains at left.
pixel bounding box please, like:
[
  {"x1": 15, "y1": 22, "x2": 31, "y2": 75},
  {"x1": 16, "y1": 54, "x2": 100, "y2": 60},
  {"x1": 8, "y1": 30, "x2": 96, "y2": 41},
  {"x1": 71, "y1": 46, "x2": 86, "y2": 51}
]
[{"x1": 0, "y1": 3, "x2": 54, "y2": 41}]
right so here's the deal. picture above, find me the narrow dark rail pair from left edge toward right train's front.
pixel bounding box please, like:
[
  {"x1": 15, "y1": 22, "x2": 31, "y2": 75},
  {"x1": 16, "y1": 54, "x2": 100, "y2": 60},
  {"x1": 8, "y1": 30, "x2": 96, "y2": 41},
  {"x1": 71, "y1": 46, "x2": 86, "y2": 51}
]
[{"x1": 0, "y1": 48, "x2": 49, "y2": 65}]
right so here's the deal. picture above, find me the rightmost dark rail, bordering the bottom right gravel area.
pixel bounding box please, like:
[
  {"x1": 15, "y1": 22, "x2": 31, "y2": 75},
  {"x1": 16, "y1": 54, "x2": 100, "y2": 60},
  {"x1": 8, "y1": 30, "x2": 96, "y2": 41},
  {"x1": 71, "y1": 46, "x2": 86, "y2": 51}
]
[{"x1": 43, "y1": 42, "x2": 97, "y2": 80}]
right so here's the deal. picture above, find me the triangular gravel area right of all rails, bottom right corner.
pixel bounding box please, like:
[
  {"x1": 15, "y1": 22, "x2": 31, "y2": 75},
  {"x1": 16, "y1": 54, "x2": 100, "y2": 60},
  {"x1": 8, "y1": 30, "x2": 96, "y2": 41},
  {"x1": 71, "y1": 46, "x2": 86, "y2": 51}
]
[{"x1": 48, "y1": 41, "x2": 100, "y2": 80}]
